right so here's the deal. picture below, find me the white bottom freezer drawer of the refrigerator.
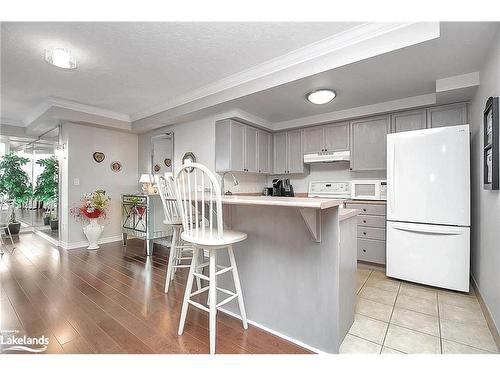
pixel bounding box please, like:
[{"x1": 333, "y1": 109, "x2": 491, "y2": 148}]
[{"x1": 386, "y1": 221, "x2": 470, "y2": 292}]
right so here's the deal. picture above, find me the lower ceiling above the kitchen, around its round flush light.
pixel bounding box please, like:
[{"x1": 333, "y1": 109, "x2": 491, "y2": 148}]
[{"x1": 229, "y1": 22, "x2": 498, "y2": 123}]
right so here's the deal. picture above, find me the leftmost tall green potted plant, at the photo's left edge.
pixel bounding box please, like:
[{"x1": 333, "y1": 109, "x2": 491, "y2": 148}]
[{"x1": 0, "y1": 153, "x2": 32, "y2": 234}]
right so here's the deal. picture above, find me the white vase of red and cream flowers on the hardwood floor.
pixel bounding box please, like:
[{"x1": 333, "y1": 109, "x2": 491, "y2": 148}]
[{"x1": 70, "y1": 189, "x2": 111, "y2": 250}]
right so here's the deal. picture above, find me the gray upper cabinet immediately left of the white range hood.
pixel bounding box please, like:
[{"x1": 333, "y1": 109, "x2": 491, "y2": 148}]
[{"x1": 273, "y1": 130, "x2": 308, "y2": 174}]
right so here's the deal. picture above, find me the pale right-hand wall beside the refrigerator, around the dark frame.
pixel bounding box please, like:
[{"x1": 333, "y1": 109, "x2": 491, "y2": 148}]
[{"x1": 470, "y1": 29, "x2": 500, "y2": 330}]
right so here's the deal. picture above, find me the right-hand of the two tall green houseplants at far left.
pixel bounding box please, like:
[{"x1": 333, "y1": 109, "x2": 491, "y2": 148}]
[{"x1": 33, "y1": 156, "x2": 59, "y2": 230}]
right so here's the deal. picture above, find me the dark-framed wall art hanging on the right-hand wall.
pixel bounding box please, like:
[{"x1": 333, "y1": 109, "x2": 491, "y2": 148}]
[{"x1": 483, "y1": 97, "x2": 499, "y2": 190}]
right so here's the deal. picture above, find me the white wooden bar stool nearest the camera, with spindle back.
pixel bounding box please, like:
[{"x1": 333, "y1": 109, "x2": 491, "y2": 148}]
[{"x1": 174, "y1": 163, "x2": 248, "y2": 354}]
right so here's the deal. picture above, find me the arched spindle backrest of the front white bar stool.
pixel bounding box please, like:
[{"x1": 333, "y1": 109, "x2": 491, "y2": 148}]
[{"x1": 174, "y1": 162, "x2": 224, "y2": 239}]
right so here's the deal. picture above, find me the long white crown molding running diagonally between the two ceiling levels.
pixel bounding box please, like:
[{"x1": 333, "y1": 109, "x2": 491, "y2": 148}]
[{"x1": 130, "y1": 22, "x2": 439, "y2": 121}]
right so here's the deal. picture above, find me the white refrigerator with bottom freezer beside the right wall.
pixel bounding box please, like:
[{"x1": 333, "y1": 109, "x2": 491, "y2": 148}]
[{"x1": 386, "y1": 125, "x2": 470, "y2": 292}]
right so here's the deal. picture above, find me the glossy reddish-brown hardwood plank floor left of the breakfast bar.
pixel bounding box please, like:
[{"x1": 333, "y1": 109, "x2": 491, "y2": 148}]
[{"x1": 0, "y1": 233, "x2": 309, "y2": 354}]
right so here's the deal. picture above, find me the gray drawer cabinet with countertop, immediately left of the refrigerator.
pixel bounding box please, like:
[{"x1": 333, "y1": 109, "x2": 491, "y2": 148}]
[{"x1": 345, "y1": 201, "x2": 386, "y2": 264}]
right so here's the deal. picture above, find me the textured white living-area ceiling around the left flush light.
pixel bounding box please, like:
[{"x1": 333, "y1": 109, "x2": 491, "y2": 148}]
[{"x1": 1, "y1": 22, "x2": 360, "y2": 121}]
